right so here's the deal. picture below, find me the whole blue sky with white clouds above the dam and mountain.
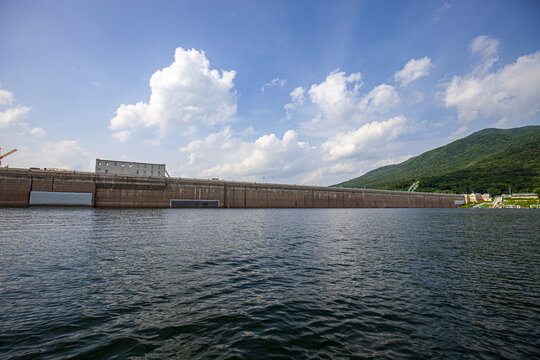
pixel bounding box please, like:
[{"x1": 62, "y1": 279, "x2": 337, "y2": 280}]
[{"x1": 0, "y1": 0, "x2": 540, "y2": 185}]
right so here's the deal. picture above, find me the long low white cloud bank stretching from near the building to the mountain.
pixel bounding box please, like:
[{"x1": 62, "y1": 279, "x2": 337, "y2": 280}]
[{"x1": 178, "y1": 115, "x2": 411, "y2": 185}]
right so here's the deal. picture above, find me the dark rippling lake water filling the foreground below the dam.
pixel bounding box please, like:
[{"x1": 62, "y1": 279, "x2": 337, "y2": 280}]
[{"x1": 0, "y1": 208, "x2": 540, "y2": 359}]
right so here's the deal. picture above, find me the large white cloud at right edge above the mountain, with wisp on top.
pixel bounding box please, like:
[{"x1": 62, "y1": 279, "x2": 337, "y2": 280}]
[{"x1": 444, "y1": 47, "x2": 540, "y2": 126}]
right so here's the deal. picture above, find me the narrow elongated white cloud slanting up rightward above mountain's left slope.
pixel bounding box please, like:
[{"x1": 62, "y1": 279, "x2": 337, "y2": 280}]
[{"x1": 322, "y1": 115, "x2": 409, "y2": 160}]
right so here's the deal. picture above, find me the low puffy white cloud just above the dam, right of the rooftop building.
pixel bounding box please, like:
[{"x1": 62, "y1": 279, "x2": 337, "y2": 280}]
[{"x1": 180, "y1": 127, "x2": 314, "y2": 181}]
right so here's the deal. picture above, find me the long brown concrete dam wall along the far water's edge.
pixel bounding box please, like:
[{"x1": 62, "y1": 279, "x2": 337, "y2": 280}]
[{"x1": 0, "y1": 168, "x2": 464, "y2": 208}]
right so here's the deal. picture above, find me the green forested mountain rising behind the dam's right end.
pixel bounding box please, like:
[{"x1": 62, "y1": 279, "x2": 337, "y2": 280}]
[{"x1": 334, "y1": 126, "x2": 540, "y2": 194}]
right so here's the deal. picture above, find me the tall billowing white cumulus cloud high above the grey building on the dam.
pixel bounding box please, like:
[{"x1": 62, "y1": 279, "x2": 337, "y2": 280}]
[{"x1": 109, "y1": 47, "x2": 236, "y2": 141}]
